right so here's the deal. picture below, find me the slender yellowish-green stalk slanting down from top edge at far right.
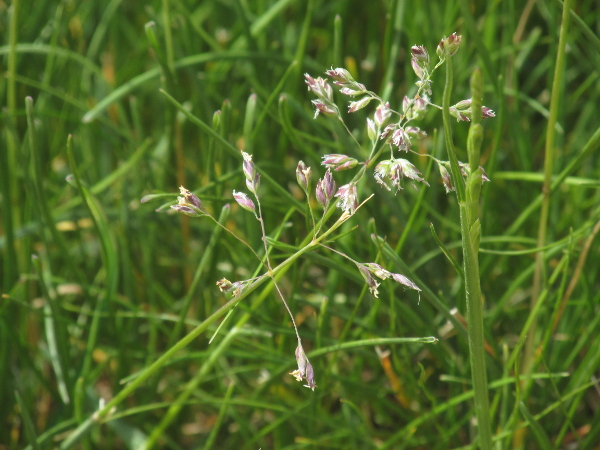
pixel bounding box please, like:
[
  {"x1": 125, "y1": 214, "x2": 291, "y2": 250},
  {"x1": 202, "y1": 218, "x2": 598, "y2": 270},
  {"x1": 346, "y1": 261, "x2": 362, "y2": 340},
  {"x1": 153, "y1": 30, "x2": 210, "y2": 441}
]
[{"x1": 523, "y1": 0, "x2": 573, "y2": 374}]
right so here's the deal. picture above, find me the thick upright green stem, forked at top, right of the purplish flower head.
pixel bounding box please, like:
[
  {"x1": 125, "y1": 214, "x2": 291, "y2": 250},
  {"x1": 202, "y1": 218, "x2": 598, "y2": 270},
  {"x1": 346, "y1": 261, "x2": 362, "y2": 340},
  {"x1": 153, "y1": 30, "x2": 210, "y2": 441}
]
[{"x1": 443, "y1": 55, "x2": 492, "y2": 450}]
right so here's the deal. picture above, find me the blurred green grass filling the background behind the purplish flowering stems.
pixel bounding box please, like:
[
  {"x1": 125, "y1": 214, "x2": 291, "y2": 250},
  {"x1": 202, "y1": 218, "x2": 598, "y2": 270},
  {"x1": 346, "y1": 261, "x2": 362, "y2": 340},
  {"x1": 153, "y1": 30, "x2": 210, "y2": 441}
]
[{"x1": 0, "y1": 0, "x2": 600, "y2": 449}]
